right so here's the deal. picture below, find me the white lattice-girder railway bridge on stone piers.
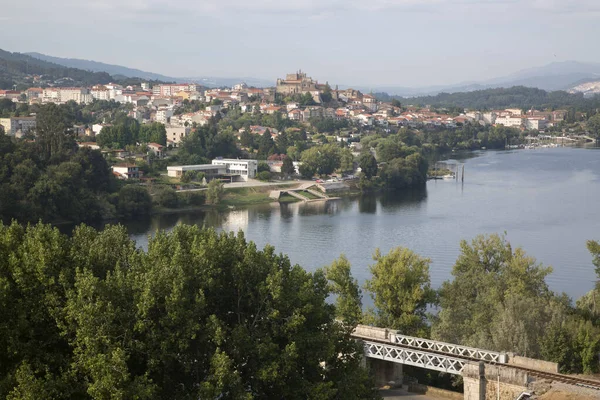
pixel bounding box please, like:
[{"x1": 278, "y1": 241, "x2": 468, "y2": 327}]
[{"x1": 352, "y1": 325, "x2": 600, "y2": 400}]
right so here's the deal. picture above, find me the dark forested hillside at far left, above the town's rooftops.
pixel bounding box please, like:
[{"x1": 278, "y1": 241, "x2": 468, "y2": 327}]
[{"x1": 0, "y1": 49, "x2": 115, "y2": 90}]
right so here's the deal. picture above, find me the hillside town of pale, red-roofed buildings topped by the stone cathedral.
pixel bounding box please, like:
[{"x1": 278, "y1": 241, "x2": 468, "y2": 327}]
[{"x1": 0, "y1": 71, "x2": 586, "y2": 185}]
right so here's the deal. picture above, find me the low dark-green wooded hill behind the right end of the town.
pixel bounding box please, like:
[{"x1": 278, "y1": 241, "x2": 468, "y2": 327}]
[{"x1": 376, "y1": 86, "x2": 600, "y2": 112}]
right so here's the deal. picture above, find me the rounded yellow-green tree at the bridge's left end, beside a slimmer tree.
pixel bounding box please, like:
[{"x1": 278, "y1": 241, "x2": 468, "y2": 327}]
[{"x1": 365, "y1": 247, "x2": 435, "y2": 337}]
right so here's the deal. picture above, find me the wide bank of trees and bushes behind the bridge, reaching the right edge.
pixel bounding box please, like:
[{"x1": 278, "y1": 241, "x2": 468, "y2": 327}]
[{"x1": 432, "y1": 235, "x2": 600, "y2": 373}]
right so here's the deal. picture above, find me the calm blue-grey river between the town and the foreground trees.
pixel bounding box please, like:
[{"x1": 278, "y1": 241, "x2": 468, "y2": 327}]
[{"x1": 127, "y1": 148, "x2": 600, "y2": 302}]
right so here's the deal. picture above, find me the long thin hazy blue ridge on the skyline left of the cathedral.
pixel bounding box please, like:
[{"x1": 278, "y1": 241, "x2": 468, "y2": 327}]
[{"x1": 26, "y1": 53, "x2": 275, "y2": 87}]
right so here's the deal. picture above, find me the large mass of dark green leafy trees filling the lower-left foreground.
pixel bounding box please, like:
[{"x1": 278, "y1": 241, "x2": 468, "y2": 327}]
[{"x1": 0, "y1": 223, "x2": 377, "y2": 399}]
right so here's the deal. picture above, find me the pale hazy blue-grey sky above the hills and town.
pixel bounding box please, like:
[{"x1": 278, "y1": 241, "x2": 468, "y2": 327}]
[{"x1": 0, "y1": 0, "x2": 600, "y2": 86}]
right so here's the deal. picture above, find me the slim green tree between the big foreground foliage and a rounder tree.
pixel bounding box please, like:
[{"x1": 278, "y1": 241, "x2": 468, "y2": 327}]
[{"x1": 325, "y1": 254, "x2": 362, "y2": 329}]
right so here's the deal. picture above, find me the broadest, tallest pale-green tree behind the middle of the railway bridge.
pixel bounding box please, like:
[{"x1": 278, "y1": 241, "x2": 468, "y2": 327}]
[{"x1": 432, "y1": 234, "x2": 552, "y2": 357}]
